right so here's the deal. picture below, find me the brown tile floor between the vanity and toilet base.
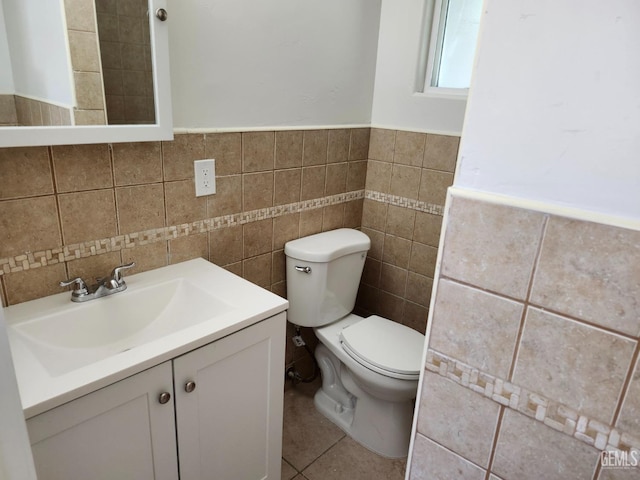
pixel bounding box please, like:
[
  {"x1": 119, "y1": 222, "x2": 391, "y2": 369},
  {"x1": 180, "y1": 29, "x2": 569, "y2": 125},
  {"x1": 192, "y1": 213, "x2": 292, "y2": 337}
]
[{"x1": 282, "y1": 378, "x2": 406, "y2": 480}]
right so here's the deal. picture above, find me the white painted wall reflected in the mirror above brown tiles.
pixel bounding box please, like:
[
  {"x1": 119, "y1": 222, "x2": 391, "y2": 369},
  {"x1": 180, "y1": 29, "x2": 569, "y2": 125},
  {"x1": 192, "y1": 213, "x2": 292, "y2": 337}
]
[{"x1": 2, "y1": 0, "x2": 74, "y2": 105}]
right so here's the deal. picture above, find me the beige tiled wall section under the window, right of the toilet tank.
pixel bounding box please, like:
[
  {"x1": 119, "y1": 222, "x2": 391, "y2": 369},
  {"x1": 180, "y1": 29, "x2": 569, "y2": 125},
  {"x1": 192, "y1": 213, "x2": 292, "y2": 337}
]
[{"x1": 357, "y1": 128, "x2": 459, "y2": 333}]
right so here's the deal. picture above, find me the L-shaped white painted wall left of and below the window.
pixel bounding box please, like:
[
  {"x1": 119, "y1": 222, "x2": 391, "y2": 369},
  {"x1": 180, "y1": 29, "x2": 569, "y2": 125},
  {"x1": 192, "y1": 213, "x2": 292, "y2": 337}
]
[{"x1": 371, "y1": 0, "x2": 466, "y2": 135}]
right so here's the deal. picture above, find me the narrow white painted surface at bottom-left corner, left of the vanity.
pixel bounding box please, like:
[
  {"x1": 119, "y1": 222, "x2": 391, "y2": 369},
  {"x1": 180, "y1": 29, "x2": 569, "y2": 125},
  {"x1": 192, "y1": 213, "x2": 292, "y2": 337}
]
[{"x1": 0, "y1": 308, "x2": 36, "y2": 480}]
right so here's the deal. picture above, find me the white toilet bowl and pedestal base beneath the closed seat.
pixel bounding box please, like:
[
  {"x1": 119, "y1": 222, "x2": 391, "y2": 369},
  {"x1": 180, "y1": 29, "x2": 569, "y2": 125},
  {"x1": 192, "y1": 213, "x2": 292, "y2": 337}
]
[{"x1": 314, "y1": 344, "x2": 414, "y2": 458}]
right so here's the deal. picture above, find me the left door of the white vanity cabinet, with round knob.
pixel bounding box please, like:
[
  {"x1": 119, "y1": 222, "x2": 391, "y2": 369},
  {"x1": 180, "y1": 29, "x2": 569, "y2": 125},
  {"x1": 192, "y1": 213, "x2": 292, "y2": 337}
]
[{"x1": 27, "y1": 362, "x2": 178, "y2": 480}]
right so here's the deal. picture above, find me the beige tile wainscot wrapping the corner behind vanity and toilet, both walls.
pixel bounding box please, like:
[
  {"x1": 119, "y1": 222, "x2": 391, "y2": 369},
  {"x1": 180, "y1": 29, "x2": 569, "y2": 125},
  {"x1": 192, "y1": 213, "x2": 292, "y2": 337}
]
[{"x1": 0, "y1": 128, "x2": 458, "y2": 363}]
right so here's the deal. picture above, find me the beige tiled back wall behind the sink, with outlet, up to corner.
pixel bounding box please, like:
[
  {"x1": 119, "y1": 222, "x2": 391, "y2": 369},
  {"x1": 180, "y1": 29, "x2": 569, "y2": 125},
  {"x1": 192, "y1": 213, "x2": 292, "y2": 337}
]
[{"x1": 0, "y1": 128, "x2": 369, "y2": 368}]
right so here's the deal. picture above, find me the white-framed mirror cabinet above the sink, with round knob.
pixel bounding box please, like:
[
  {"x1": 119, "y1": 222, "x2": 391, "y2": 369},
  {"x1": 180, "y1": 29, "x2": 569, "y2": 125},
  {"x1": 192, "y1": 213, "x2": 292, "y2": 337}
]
[{"x1": 0, "y1": 0, "x2": 173, "y2": 147}]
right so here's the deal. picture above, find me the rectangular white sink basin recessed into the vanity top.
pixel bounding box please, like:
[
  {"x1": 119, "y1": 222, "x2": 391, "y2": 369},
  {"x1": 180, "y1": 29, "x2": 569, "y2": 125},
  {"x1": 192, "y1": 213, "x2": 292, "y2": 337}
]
[{"x1": 14, "y1": 278, "x2": 231, "y2": 376}]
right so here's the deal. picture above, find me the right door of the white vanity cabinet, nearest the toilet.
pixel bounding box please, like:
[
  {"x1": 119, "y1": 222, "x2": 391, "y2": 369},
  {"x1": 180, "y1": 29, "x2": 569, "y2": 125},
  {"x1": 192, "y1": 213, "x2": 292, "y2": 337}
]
[{"x1": 174, "y1": 313, "x2": 286, "y2": 480}]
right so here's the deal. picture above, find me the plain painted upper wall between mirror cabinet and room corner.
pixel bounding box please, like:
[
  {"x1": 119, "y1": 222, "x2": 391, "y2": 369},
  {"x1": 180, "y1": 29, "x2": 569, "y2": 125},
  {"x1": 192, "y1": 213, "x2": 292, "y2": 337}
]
[{"x1": 168, "y1": 0, "x2": 381, "y2": 129}]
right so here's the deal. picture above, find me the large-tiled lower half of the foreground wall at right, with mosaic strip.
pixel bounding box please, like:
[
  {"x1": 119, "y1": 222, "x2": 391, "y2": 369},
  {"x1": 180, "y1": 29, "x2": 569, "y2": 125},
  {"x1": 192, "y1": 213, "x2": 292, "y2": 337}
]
[{"x1": 410, "y1": 190, "x2": 640, "y2": 480}]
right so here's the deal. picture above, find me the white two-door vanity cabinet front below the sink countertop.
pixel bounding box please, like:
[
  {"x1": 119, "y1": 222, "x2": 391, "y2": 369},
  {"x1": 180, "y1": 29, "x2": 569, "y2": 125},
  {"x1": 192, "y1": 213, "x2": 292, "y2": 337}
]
[{"x1": 27, "y1": 313, "x2": 285, "y2": 480}]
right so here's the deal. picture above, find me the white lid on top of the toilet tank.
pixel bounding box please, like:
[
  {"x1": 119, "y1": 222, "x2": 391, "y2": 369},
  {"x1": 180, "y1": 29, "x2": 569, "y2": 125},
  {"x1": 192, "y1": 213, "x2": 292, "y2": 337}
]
[{"x1": 284, "y1": 228, "x2": 371, "y2": 262}]
